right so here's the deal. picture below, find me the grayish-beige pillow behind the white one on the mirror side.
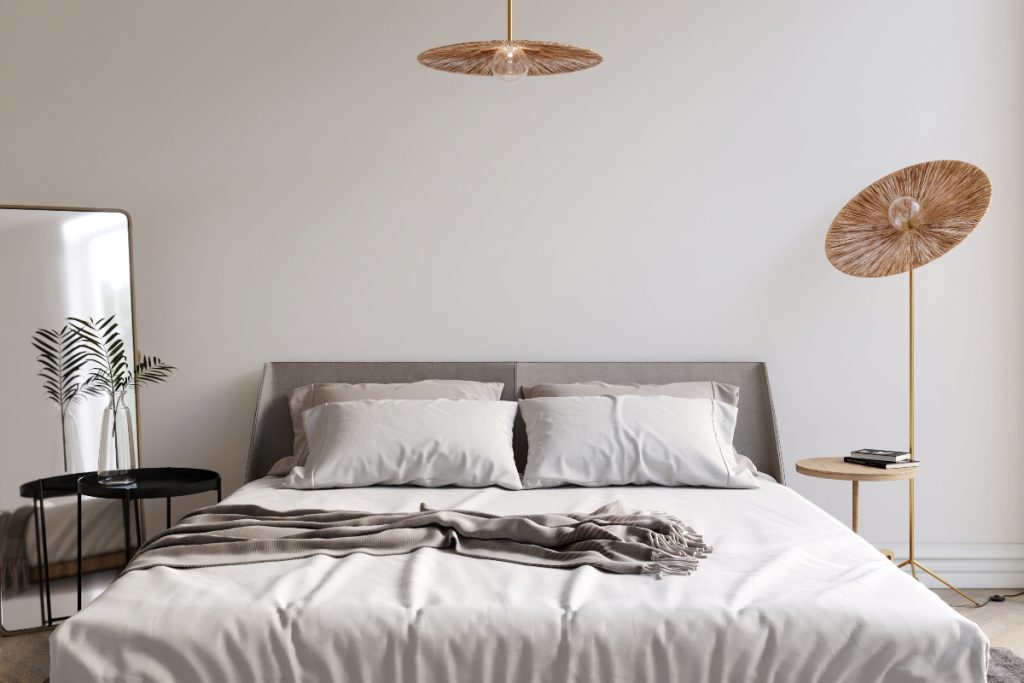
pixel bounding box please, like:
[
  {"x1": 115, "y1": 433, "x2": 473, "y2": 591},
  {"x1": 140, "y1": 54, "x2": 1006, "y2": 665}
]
[{"x1": 280, "y1": 380, "x2": 505, "y2": 476}]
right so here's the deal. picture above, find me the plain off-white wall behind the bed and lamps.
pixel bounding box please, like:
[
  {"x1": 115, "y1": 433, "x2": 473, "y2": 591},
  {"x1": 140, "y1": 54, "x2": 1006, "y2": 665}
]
[{"x1": 0, "y1": 0, "x2": 1024, "y2": 577}]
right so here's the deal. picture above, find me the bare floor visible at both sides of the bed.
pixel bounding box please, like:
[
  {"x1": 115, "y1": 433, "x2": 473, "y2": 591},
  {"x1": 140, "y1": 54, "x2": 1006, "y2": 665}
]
[{"x1": 0, "y1": 588, "x2": 1024, "y2": 683}]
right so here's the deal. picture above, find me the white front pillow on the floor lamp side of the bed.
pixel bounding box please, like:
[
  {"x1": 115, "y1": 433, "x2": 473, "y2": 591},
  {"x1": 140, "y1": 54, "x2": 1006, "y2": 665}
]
[{"x1": 519, "y1": 396, "x2": 759, "y2": 488}]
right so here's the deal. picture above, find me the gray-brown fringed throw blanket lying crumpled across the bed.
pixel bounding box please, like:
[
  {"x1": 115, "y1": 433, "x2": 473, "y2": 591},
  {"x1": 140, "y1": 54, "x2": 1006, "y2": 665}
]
[{"x1": 125, "y1": 502, "x2": 712, "y2": 579}]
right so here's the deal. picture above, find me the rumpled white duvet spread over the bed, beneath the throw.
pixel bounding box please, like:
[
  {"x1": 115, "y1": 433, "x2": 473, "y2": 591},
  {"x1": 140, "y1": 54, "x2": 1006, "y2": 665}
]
[{"x1": 50, "y1": 478, "x2": 988, "y2": 683}]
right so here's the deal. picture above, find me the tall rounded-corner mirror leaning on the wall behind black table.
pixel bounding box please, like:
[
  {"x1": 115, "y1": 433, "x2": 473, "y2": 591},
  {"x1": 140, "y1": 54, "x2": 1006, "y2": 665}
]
[{"x1": 0, "y1": 207, "x2": 138, "y2": 633}]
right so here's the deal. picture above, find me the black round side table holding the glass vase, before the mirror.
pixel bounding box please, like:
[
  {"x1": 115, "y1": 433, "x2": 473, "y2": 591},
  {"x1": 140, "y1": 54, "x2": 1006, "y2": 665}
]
[{"x1": 78, "y1": 467, "x2": 220, "y2": 609}]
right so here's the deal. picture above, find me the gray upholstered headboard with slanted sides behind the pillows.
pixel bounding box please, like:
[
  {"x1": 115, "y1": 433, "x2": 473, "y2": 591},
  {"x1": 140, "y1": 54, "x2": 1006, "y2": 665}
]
[{"x1": 246, "y1": 362, "x2": 784, "y2": 481}]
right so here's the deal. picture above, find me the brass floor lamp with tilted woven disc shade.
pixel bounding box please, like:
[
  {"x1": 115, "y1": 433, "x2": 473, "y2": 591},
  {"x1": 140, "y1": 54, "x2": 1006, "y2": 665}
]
[{"x1": 825, "y1": 161, "x2": 992, "y2": 605}]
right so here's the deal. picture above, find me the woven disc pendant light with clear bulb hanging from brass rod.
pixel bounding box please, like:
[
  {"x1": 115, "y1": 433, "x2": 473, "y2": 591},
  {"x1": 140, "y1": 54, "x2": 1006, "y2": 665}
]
[{"x1": 417, "y1": 0, "x2": 601, "y2": 81}]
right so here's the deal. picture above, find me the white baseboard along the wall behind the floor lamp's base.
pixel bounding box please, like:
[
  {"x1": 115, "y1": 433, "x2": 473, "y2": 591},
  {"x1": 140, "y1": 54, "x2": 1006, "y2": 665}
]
[{"x1": 880, "y1": 543, "x2": 1024, "y2": 590}]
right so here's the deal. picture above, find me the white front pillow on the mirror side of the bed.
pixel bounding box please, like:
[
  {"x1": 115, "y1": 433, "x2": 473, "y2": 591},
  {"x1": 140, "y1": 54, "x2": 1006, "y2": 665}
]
[{"x1": 284, "y1": 398, "x2": 522, "y2": 489}]
